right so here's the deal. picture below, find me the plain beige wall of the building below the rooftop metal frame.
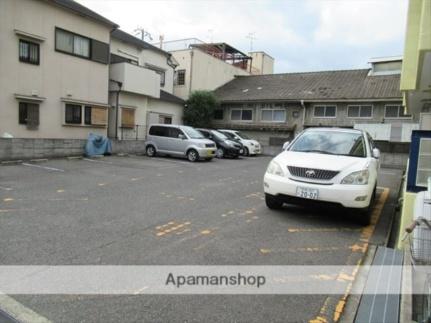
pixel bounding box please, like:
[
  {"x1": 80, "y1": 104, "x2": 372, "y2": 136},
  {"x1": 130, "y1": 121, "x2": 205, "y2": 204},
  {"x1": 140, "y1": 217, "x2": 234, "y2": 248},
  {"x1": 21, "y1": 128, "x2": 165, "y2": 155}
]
[{"x1": 172, "y1": 49, "x2": 250, "y2": 99}]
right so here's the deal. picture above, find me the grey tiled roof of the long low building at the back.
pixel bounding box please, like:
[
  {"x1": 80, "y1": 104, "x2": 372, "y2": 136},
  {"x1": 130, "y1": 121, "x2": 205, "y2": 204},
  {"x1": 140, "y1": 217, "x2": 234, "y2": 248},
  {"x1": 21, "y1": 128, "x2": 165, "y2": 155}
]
[{"x1": 215, "y1": 69, "x2": 402, "y2": 102}]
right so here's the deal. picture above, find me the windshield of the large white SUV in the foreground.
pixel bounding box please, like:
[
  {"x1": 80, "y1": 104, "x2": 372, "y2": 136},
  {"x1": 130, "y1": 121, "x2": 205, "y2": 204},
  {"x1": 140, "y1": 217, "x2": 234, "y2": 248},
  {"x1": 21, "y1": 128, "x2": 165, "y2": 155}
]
[{"x1": 289, "y1": 131, "x2": 366, "y2": 157}]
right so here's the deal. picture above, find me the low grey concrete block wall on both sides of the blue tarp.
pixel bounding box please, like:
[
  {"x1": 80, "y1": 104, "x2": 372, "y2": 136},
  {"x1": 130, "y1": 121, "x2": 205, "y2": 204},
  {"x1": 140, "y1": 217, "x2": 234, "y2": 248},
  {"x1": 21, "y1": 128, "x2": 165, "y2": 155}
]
[{"x1": 0, "y1": 138, "x2": 145, "y2": 161}]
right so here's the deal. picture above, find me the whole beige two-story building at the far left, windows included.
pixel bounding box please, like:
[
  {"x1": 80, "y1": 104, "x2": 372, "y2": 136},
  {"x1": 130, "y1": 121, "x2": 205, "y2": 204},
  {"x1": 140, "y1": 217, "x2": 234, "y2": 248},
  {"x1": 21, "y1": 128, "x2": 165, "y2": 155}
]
[{"x1": 0, "y1": 0, "x2": 117, "y2": 138}]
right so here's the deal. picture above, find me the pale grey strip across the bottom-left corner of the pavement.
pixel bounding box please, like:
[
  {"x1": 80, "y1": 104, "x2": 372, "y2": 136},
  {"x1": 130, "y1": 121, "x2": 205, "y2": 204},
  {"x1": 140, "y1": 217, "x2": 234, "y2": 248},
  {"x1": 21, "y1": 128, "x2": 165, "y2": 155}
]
[{"x1": 0, "y1": 292, "x2": 51, "y2": 323}]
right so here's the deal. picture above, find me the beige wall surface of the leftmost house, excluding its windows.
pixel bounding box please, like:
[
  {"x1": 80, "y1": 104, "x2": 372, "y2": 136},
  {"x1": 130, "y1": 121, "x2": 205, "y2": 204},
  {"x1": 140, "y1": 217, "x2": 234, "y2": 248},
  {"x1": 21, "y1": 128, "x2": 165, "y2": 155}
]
[{"x1": 0, "y1": 0, "x2": 110, "y2": 138}]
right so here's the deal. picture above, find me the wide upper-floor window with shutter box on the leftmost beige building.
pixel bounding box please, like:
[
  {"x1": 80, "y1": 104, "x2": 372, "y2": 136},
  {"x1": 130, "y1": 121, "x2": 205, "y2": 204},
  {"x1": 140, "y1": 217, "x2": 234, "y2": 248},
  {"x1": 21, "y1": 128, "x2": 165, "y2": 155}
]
[{"x1": 55, "y1": 28, "x2": 109, "y2": 64}]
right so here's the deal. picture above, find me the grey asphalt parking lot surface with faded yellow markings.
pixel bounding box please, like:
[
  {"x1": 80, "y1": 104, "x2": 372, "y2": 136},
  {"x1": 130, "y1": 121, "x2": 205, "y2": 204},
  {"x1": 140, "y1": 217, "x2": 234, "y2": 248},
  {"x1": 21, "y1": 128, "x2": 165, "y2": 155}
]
[{"x1": 0, "y1": 156, "x2": 401, "y2": 322}]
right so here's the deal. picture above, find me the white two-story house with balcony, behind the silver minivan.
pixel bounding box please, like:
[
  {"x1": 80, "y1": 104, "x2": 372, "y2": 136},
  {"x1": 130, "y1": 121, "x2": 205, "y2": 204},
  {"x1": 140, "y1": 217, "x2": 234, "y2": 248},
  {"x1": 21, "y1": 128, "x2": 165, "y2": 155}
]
[{"x1": 108, "y1": 29, "x2": 184, "y2": 139}]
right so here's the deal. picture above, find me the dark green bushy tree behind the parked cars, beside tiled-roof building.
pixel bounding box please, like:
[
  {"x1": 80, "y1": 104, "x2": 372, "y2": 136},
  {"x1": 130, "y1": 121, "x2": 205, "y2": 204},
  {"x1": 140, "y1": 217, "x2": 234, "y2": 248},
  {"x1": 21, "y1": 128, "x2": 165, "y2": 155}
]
[{"x1": 183, "y1": 91, "x2": 220, "y2": 128}]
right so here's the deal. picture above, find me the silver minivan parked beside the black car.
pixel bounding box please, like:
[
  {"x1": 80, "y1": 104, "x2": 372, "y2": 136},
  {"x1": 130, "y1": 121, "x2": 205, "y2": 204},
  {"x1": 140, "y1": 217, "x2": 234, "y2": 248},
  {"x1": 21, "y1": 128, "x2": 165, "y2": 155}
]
[{"x1": 145, "y1": 124, "x2": 216, "y2": 162}]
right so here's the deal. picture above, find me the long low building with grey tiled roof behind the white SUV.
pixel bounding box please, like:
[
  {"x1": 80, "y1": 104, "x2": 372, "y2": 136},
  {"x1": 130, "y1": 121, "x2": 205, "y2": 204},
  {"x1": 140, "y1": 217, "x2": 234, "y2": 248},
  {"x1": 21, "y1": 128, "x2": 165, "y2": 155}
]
[{"x1": 213, "y1": 58, "x2": 419, "y2": 145}]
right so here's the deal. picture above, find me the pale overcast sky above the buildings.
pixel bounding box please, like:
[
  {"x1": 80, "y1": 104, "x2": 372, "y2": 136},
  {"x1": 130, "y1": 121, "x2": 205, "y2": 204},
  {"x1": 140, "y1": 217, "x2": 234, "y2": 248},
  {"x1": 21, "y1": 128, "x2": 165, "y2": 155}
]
[{"x1": 78, "y1": 0, "x2": 408, "y2": 73}]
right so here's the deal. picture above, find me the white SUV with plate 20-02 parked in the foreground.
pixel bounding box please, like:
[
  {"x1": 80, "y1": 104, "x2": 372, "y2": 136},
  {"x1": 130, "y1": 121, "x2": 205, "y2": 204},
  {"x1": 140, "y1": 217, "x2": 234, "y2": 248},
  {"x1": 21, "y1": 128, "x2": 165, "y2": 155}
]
[{"x1": 264, "y1": 128, "x2": 380, "y2": 224}]
